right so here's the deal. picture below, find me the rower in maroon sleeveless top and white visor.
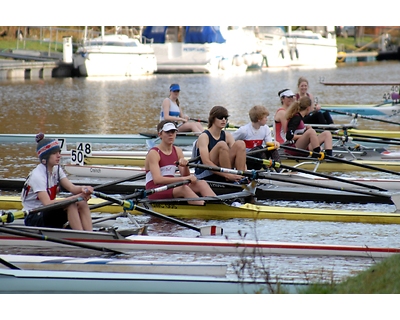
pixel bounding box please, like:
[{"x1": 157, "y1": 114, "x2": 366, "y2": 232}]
[{"x1": 145, "y1": 120, "x2": 215, "y2": 205}]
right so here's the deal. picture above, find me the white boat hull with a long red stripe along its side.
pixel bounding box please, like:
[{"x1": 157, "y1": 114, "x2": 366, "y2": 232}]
[{"x1": 0, "y1": 227, "x2": 400, "y2": 258}]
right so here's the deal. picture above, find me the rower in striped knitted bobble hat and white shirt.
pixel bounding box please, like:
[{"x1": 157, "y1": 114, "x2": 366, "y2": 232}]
[{"x1": 21, "y1": 133, "x2": 93, "y2": 231}]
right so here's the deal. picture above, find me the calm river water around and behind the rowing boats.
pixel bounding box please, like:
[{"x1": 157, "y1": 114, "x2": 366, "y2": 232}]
[{"x1": 0, "y1": 62, "x2": 400, "y2": 284}]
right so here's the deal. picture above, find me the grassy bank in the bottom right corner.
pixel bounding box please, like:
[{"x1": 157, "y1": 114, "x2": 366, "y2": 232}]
[{"x1": 301, "y1": 254, "x2": 400, "y2": 294}]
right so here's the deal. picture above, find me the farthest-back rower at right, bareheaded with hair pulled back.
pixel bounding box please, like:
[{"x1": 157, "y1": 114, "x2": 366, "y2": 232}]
[{"x1": 296, "y1": 77, "x2": 333, "y2": 124}]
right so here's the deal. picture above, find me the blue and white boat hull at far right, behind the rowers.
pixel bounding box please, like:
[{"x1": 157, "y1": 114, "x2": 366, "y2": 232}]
[{"x1": 321, "y1": 103, "x2": 400, "y2": 116}]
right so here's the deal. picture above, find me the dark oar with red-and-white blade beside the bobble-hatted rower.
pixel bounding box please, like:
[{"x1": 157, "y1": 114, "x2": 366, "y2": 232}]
[{"x1": 93, "y1": 191, "x2": 223, "y2": 236}]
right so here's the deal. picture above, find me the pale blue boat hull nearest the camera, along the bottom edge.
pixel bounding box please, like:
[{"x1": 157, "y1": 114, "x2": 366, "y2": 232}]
[{"x1": 0, "y1": 269, "x2": 296, "y2": 294}]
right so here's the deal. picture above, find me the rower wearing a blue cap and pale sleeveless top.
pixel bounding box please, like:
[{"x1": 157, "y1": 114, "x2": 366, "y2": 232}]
[{"x1": 160, "y1": 83, "x2": 204, "y2": 132}]
